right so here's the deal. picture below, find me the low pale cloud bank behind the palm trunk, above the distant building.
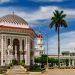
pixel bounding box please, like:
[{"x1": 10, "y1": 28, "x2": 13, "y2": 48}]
[{"x1": 49, "y1": 31, "x2": 75, "y2": 54}]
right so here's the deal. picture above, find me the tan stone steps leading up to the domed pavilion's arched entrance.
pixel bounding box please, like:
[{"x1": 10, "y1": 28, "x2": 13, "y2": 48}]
[{"x1": 6, "y1": 66, "x2": 29, "y2": 75}]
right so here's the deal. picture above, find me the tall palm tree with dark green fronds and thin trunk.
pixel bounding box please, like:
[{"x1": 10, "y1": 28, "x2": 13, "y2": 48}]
[{"x1": 49, "y1": 10, "x2": 67, "y2": 68}]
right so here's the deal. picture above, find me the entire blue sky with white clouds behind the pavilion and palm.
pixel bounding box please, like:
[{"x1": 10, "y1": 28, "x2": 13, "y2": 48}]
[{"x1": 0, "y1": 0, "x2": 75, "y2": 54}]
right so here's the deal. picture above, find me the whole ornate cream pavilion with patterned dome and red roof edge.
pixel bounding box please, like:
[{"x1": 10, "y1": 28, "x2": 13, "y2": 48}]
[{"x1": 0, "y1": 14, "x2": 36, "y2": 66}]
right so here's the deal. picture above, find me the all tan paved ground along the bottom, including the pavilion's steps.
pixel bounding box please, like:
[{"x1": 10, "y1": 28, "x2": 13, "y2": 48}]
[{"x1": 6, "y1": 66, "x2": 75, "y2": 75}]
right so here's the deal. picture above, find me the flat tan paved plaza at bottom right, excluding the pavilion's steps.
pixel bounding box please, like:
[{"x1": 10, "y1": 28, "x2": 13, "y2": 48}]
[{"x1": 31, "y1": 69, "x2": 75, "y2": 75}]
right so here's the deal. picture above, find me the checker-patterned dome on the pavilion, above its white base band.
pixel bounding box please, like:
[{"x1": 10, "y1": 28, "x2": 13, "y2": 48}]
[{"x1": 0, "y1": 14, "x2": 28, "y2": 25}]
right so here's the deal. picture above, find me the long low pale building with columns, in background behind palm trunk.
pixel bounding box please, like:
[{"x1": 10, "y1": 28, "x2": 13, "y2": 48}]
[{"x1": 49, "y1": 51, "x2": 75, "y2": 66}]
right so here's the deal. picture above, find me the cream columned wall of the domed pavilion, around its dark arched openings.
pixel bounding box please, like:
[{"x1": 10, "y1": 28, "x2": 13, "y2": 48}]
[{"x1": 0, "y1": 34, "x2": 34, "y2": 66}]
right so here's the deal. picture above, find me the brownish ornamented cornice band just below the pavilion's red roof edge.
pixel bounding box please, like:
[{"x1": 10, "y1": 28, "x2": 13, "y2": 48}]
[{"x1": 0, "y1": 28, "x2": 36, "y2": 38}]
